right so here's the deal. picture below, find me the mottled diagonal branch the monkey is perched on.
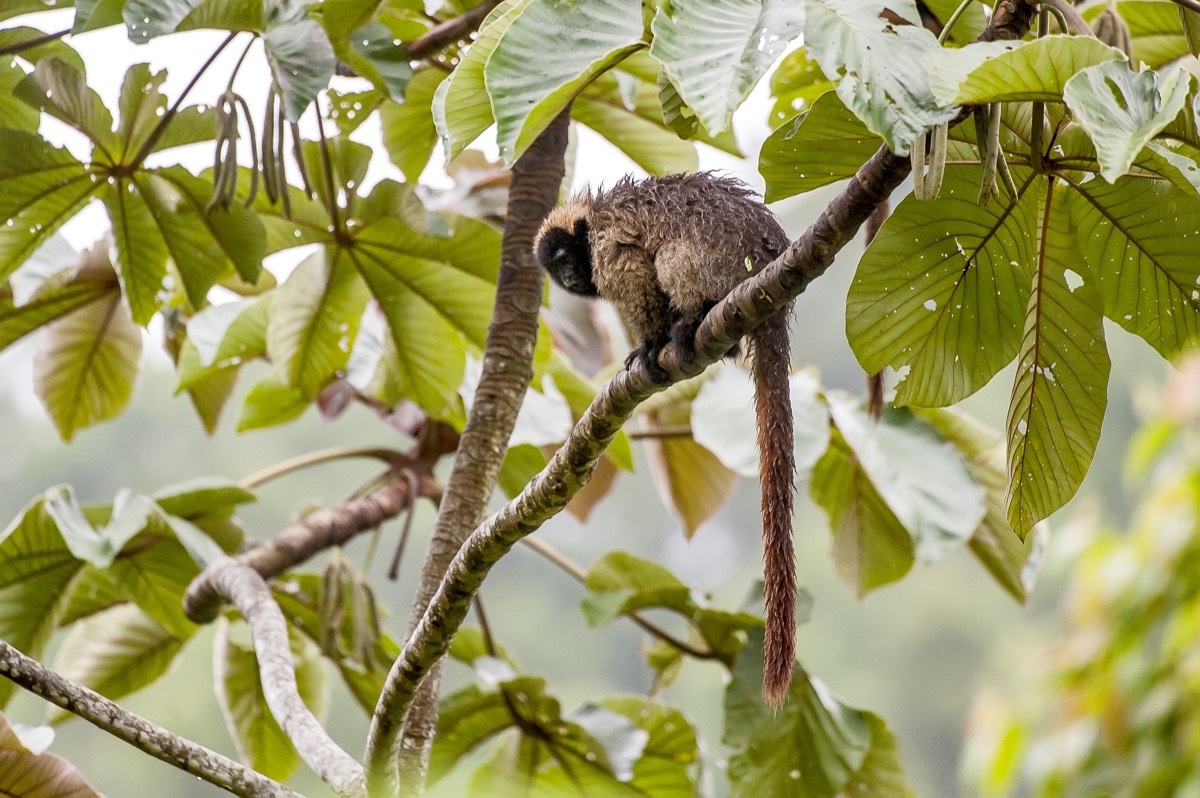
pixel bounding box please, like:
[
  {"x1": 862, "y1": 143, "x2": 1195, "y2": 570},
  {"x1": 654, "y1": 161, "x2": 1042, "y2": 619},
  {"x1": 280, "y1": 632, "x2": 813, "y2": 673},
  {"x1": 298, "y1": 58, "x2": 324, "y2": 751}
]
[{"x1": 367, "y1": 0, "x2": 1034, "y2": 781}]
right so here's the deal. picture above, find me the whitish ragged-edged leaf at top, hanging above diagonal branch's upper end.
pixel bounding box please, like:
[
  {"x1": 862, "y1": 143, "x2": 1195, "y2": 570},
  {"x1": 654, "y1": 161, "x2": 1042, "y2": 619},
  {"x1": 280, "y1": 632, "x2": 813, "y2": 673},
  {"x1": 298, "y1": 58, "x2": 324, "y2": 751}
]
[{"x1": 804, "y1": 0, "x2": 956, "y2": 155}]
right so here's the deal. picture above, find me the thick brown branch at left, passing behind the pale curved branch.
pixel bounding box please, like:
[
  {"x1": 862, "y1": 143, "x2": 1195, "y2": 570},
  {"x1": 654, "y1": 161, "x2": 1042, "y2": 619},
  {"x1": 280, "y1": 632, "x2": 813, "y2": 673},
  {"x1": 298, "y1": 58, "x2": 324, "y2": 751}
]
[{"x1": 184, "y1": 475, "x2": 438, "y2": 624}]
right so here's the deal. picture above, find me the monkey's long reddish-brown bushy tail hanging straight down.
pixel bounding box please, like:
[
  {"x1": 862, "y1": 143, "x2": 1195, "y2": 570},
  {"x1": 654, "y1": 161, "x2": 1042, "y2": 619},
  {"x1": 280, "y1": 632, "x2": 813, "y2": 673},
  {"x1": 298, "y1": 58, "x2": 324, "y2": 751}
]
[{"x1": 751, "y1": 311, "x2": 796, "y2": 708}]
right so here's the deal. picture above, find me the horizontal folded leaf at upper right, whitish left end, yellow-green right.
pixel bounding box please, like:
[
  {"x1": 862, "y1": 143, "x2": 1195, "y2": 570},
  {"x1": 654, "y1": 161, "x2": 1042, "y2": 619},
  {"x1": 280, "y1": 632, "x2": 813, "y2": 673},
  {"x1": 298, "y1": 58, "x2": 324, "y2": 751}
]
[{"x1": 924, "y1": 36, "x2": 1123, "y2": 106}]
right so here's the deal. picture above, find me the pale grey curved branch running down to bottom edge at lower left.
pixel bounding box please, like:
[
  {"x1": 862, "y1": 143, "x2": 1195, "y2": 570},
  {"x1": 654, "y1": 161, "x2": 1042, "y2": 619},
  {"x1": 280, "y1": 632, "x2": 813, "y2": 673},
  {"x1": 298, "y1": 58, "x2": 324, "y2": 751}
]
[{"x1": 206, "y1": 557, "x2": 366, "y2": 797}]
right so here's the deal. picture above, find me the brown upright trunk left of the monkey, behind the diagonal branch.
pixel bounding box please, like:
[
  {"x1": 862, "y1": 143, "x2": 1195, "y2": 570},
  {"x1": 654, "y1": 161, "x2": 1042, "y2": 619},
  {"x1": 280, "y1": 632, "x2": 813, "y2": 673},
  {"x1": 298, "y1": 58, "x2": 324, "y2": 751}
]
[{"x1": 366, "y1": 109, "x2": 570, "y2": 794}]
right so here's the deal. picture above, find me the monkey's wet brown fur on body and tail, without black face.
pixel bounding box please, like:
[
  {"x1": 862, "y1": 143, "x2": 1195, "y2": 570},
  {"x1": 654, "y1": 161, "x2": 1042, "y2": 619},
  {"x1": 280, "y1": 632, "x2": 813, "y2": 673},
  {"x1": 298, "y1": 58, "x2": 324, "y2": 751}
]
[{"x1": 534, "y1": 173, "x2": 796, "y2": 707}]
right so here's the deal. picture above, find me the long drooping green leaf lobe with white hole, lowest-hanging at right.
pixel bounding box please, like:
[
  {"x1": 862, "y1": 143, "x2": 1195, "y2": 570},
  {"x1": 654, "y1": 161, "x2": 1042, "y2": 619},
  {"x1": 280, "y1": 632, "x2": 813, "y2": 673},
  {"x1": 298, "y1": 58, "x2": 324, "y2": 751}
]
[{"x1": 1008, "y1": 184, "x2": 1104, "y2": 536}]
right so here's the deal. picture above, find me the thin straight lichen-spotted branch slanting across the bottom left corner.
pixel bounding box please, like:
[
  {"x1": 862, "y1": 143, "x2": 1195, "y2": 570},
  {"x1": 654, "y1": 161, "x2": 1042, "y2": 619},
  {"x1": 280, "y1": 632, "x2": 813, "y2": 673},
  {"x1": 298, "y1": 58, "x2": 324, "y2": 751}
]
[{"x1": 0, "y1": 640, "x2": 304, "y2": 798}]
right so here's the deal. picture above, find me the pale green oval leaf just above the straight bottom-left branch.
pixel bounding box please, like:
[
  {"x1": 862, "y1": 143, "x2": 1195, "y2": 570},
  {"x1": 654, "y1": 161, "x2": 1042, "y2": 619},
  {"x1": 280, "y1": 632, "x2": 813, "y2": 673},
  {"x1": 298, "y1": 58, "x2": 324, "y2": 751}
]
[{"x1": 48, "y1": 604, "x2": 186, "y2": 722}]
